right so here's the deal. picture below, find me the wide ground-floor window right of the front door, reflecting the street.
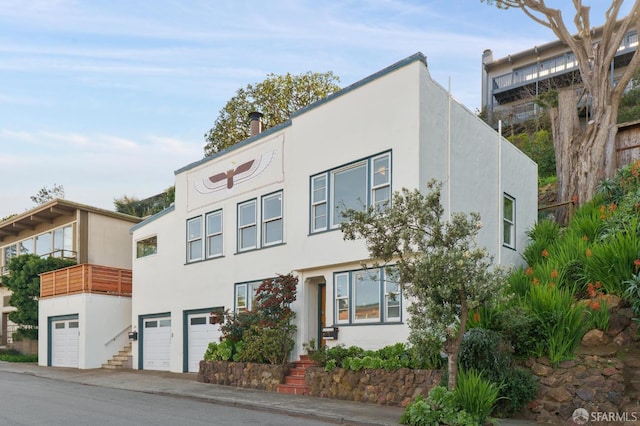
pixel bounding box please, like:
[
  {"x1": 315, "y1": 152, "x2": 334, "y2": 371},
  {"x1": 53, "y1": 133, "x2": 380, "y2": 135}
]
[{"x1": 334, "y1": 268, "x2": 402, "y2": 324}]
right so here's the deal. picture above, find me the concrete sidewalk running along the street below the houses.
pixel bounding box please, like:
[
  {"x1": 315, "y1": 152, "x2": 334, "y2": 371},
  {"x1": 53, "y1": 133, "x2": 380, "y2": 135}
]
[{"x1": 0, "y1": 362, "x2": 535, "y2": 426}]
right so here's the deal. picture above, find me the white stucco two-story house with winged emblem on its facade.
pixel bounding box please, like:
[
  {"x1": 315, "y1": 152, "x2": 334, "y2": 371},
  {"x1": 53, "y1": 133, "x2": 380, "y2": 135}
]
[{"x1": 132, "y1": 53, "x2": 537, "y2": 372}]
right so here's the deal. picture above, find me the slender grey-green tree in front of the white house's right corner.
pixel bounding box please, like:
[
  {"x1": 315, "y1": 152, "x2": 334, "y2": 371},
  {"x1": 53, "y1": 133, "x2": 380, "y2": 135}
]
[{"x1": 340, "y1": 181, "x2": 506, "y2": 389}]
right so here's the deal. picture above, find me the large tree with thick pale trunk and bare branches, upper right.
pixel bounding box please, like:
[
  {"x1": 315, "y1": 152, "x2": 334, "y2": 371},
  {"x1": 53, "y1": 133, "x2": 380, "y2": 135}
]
[{"x1": 481, "y1": 0, "x2": 640, "y2": 204}]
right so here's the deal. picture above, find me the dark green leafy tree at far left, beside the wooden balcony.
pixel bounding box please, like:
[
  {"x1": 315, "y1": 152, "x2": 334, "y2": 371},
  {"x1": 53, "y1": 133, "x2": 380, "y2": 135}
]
[{"x1": 2, "y1": 254, "x2": 76, "y2": 338}]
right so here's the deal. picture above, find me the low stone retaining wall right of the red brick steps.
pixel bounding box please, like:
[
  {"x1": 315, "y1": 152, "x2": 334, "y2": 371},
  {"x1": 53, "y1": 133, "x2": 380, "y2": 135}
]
[{"x1": 305, "y1": 367, "x2": 442, "y2": 407}]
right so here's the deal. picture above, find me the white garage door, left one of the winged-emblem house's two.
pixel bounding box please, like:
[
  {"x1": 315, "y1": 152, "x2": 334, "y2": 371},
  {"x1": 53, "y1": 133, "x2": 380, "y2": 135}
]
[{"x1": 142, "y1": 317, "x2": 171, "y2": 371}]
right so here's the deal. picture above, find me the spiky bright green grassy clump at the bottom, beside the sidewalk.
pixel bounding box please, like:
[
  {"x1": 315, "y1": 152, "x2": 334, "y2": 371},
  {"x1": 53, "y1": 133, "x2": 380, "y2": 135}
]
[{"x1": 455, "y1": 369, "x2": 499, "y2": 425}]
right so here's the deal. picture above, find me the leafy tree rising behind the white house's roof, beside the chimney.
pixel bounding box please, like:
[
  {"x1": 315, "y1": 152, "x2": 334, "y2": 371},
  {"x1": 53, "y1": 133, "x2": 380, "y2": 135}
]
[{"x1": 204, "y1": 71, "x2": 340, "y2": 157}]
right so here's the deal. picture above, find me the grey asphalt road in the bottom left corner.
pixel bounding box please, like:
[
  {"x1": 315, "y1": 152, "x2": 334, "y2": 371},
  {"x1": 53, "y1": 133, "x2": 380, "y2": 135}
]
[{"x1": 0, "y1": 372, "x2": 329, "y2": 426}]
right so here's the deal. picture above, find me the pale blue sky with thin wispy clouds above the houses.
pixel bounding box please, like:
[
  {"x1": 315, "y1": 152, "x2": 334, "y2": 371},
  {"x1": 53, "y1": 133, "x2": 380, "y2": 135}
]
[{"x1": 0, "y1": 0, "x2": 632, "y2": 218}]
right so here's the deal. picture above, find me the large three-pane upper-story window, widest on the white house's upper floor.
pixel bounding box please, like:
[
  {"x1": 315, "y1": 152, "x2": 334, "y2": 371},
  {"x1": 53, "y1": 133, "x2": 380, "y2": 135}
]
[{"x1": 310, "y1": 152, "x2": 391, "y2": 233}]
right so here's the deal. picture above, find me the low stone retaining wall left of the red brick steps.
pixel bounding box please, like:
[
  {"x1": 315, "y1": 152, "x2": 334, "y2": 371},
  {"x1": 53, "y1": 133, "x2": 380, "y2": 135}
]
[{"x1": 198, "y1": 361, "x2": 289, "y2": 392}]
